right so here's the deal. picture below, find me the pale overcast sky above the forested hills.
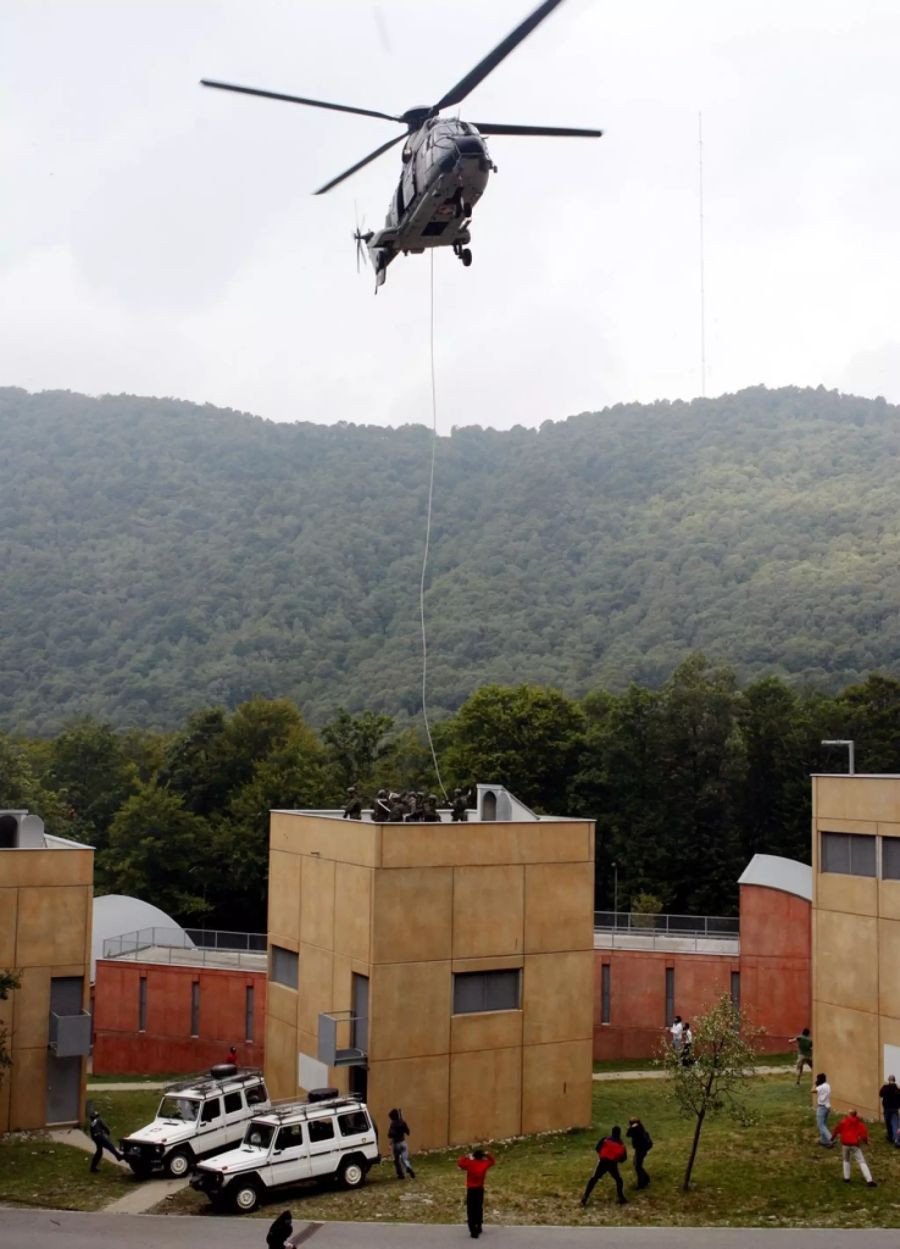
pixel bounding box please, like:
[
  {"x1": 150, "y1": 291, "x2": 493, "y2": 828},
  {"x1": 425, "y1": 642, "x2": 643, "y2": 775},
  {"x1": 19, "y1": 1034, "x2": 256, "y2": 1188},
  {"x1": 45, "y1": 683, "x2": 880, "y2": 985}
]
[{"x1": 0, "y1": 0, "x2": 900, "y2": 431}]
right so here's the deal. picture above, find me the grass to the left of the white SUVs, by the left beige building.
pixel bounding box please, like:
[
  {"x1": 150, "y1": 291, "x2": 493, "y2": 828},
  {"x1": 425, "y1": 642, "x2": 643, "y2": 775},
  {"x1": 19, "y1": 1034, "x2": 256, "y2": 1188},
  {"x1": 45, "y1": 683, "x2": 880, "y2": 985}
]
[{"x1": 0, "y1": 1089, "x2": 167, "y2": 1210}]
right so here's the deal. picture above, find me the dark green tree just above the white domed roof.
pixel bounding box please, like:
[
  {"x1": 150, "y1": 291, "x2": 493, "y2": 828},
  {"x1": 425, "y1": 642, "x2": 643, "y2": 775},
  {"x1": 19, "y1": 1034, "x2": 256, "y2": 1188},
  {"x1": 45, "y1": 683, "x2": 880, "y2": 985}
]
[{"x1": 99, "y1": 782, "x2": 212, "y2": 924}]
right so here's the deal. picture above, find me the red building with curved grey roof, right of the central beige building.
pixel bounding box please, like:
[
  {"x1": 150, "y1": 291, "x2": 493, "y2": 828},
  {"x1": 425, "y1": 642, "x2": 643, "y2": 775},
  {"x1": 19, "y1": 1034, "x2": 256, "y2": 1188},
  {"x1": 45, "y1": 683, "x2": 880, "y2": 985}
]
[{"x1": 594, "y1": 854, "x2": 813, "y2": 1059}]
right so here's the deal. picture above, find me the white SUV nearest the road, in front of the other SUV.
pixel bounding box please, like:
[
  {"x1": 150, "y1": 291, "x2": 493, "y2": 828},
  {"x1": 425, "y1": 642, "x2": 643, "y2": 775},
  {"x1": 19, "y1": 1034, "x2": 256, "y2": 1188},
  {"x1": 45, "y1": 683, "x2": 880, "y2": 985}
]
[{"x1": 191, "y1": 1097, "x2": 381, "y2": 1214}]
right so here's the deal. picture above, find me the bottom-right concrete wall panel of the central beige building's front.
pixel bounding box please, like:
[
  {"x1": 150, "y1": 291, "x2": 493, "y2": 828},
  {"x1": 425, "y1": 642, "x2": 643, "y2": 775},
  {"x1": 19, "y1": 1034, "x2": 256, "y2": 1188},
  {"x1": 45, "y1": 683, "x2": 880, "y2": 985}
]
[{"x1": 522, "y1": 1040, "x2": 593, "y2": 1133}]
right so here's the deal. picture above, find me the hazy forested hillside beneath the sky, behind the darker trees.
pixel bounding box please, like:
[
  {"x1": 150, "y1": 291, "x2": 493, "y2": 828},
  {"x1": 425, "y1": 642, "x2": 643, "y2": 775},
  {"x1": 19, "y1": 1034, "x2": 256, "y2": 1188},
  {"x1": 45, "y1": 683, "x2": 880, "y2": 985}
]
[{"x1": 0, "y1": 387, "x2": 900, "y2": 734}]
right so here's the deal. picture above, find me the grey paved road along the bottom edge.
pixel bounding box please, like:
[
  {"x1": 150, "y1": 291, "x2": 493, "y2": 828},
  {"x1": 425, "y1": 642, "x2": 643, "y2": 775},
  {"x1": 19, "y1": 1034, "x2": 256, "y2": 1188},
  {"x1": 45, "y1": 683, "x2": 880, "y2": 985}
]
[{"x1": 0, "y1": 1208, "x2": 898, "y2": 1249}]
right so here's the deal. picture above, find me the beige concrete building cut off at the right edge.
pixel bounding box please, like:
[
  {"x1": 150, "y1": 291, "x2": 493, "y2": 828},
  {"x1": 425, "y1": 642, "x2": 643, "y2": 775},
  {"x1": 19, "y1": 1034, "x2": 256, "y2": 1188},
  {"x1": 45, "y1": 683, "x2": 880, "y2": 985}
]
[{"x1": 813, "y1": 774, "x2": 900, "y2": 1118}]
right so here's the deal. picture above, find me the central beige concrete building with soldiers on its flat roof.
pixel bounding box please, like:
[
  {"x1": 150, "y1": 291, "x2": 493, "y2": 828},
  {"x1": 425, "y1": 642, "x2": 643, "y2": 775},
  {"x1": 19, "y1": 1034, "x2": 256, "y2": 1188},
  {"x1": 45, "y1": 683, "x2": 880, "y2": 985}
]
[{"x1": 266, "y1": 786, "x2": 594, "y2": 1149}]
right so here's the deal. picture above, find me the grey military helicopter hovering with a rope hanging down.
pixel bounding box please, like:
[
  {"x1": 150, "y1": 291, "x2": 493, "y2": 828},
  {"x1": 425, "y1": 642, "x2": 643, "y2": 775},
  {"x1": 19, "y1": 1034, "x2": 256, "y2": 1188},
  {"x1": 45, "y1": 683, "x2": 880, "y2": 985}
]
[{"x1": 201, "y1": 0, "x2": 603, "y2": 291}]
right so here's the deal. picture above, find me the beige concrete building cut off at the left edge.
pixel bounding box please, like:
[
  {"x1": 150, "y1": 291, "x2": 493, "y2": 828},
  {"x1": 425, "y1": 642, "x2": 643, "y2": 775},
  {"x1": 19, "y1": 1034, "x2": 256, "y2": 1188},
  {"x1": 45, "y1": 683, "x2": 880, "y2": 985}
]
[{"x1": 0, "y1": 811, "x2": 94, "y2": 1132}]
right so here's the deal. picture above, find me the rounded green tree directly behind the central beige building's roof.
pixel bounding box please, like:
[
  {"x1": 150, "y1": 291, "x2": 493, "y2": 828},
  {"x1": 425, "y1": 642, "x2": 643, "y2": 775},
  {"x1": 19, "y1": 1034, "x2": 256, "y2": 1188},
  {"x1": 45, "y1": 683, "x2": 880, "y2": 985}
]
[{"x1": 441, "y1": 686, "x2": 584, "y2": 816}]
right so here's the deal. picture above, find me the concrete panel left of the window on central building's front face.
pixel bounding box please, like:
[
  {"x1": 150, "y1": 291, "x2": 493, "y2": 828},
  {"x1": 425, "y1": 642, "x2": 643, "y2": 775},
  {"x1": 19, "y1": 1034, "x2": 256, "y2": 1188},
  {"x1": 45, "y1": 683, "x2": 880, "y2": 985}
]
[{"x1": 368, "y1": 962, "x2": 452, "y2": 1060}]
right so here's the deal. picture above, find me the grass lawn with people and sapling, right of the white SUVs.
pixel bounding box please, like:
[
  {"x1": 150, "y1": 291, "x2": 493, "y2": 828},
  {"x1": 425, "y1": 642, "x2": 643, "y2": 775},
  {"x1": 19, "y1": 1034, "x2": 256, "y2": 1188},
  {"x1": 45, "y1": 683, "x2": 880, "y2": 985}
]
[{"x1": 157, "y1": 1075, "x2": 900, "y2": 1228}]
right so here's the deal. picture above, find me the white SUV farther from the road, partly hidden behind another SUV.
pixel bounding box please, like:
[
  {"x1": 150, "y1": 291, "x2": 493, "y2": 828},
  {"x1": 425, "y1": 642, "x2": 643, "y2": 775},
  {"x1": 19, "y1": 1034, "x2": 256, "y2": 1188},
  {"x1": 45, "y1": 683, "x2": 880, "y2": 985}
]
[{"x1": 120, "y1": 1063, "x2": 271, "y2": 1179}]
